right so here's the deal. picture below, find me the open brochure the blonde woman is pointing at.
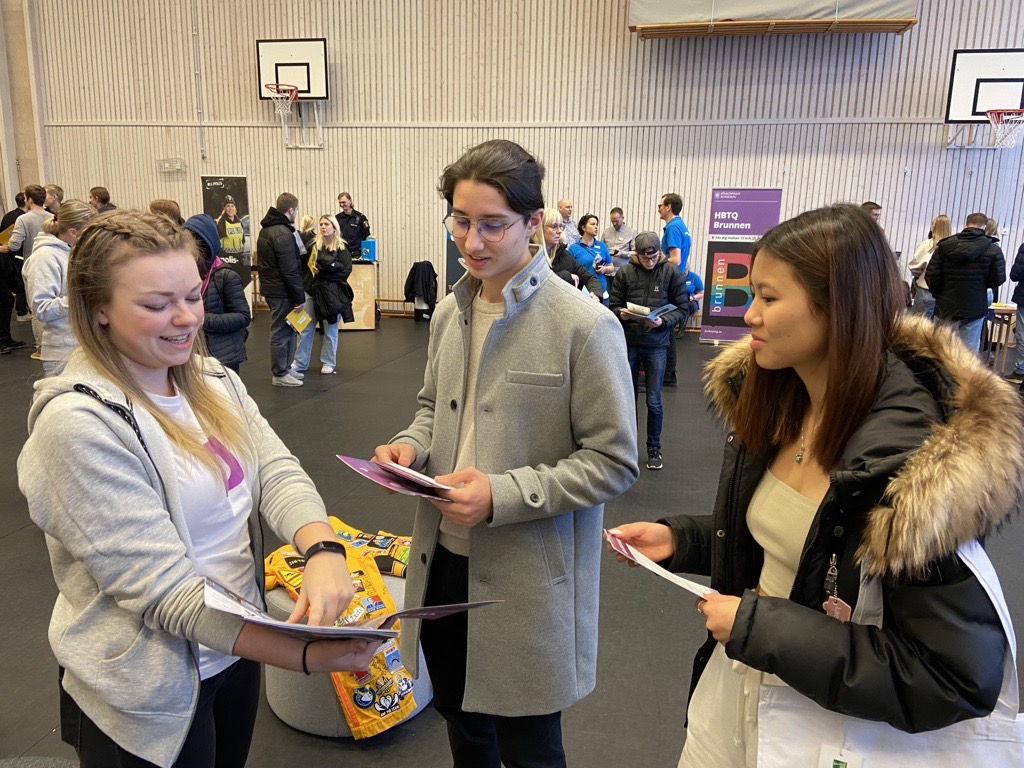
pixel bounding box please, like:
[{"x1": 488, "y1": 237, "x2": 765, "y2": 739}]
[{"x1": 203, "y1": 579, "x2": 502, "y2": 640}]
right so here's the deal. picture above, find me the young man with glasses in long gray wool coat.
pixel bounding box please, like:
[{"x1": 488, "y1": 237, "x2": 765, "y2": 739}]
[{"x1": 375, "y1": 140, "x2": 638, "y2": 768}]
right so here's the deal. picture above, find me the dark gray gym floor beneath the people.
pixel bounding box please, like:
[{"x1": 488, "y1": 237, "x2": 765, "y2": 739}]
[{"x1": 0, "y1": 312, "x2": 1024, "y2": 768}]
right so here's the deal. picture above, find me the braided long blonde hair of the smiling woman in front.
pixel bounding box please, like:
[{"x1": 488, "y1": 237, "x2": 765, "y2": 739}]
[{"x1": 65, "y1": 210, "x2": 254, "y2": 473}]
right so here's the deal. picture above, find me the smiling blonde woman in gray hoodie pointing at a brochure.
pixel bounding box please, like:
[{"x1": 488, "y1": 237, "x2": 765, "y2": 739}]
[{"x1": 17, "y1": 211, "x2": 376, "y2": 768}]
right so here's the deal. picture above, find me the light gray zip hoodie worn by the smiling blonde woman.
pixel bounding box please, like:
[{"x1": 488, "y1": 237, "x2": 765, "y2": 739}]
[{"x1": 17, "y1": 349, "x2": 327, "y2": 766}]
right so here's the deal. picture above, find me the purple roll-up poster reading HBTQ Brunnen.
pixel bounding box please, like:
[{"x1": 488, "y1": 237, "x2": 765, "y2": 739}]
[{"x1": 700, "y1": 188, "x2": 782, "y2": 344}]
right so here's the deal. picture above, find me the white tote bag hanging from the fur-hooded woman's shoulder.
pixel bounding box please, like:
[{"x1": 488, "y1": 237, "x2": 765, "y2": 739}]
[{"x1": 758, "y1": 542, "x2": 1024, "y2": 768}]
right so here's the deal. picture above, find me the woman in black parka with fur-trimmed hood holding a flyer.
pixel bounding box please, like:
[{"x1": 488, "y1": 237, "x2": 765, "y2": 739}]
[{"x1": 609, "y1": 205, "x2": 1024, "y2": 768}]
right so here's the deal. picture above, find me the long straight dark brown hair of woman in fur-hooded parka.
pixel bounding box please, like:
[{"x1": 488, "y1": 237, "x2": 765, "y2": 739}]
[{"x1": 733, "y1": 205, "x2": 905, "y2": 468}]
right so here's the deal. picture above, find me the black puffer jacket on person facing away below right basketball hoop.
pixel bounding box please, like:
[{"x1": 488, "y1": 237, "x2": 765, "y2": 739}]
[{"x1": 925, "y1": 226, "x2": 1007, "y2": 321}]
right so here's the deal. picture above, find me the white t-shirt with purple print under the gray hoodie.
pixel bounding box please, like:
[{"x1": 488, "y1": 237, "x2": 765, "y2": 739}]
[{"x1": 150, "y1": 393, "x2": 260, "y2": 680}]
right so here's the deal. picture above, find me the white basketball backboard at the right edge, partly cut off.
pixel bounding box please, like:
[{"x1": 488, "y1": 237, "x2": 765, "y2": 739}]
[{"x1": 945, "y1": 48, "x2": 1024, "y2": 124}]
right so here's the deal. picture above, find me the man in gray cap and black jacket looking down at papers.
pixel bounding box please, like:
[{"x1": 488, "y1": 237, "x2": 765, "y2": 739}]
[{"x1": 608, "y1": 232, "x2": 687, "y2": 470}]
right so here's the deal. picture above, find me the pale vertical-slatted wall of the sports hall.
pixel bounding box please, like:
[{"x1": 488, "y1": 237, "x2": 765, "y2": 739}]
[{"x1": 4, "y1": 0, "x2": 1024, "y2": 296}]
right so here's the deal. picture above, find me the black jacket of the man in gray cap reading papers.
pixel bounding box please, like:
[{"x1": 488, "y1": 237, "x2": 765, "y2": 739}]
[{"x1": 608, "y1": 256, "x2": 689, "y2": 348}]
